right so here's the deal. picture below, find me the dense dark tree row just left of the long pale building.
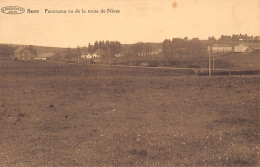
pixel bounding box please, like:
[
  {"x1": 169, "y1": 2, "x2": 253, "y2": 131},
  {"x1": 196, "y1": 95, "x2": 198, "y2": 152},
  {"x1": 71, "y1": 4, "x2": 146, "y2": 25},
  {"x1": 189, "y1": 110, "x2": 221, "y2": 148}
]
[{"x1": 162, "y1": 37, "x2": 204, "y2": 58}]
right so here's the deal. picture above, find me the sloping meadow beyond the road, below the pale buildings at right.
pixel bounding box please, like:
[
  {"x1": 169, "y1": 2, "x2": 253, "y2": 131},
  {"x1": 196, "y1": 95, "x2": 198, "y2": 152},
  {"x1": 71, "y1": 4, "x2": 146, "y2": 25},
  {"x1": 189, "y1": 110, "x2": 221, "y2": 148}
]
[{"x1": 111, "y1": 52, "x2": 260, "y2": 70}]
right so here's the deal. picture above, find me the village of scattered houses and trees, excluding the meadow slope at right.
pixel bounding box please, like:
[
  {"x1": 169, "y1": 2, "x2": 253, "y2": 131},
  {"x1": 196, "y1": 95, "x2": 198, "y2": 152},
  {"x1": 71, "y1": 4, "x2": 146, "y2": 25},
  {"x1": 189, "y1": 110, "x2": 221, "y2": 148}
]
[{"x1": 1, "y1": 35, "x2": 260, "y2": 68}]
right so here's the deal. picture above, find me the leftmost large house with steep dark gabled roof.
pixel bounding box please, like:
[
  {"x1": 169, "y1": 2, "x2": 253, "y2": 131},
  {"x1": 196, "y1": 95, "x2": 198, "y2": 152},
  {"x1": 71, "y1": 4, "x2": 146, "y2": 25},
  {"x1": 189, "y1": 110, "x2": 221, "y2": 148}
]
[{"x1": 12, "y1": 46, "x2": 36, "y2": 61}]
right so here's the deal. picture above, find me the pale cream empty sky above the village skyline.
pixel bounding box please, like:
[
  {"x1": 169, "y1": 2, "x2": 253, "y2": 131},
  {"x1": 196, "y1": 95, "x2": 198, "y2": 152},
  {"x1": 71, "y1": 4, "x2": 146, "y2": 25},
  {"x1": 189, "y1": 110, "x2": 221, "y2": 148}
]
[{"x1": 0, "y1": 0, "x2": 260, "y2": 47}]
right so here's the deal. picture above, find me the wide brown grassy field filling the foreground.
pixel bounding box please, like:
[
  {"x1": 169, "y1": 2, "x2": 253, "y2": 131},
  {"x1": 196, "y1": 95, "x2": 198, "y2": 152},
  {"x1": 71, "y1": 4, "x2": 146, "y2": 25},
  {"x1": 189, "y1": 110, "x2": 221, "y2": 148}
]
[{"x1": 0, "y1": 62, "x2": 260, "y2": 167}]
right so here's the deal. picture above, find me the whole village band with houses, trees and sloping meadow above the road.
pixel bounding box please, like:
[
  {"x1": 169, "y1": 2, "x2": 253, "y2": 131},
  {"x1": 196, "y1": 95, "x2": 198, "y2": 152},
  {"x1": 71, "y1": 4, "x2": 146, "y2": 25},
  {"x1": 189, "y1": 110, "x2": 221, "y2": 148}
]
[{"x1": 1, "y1": 38, "x2": 260, "y2": 75}]
